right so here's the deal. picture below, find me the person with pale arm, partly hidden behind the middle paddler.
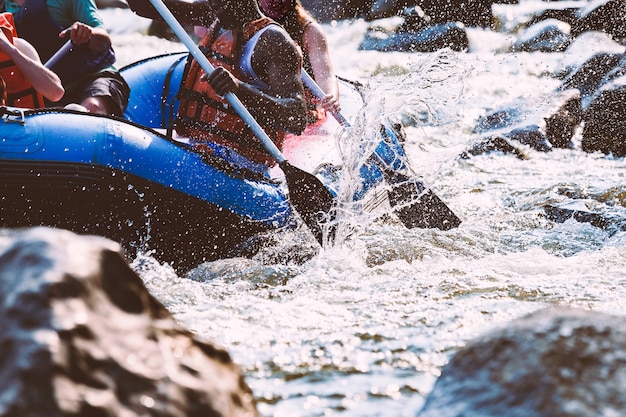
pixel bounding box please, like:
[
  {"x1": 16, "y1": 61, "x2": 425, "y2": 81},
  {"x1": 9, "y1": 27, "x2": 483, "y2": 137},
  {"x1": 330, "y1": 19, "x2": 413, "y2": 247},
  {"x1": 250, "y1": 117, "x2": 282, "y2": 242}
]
[{"x1": 259, "y1": 0, "x2": 341, "y2": 122}]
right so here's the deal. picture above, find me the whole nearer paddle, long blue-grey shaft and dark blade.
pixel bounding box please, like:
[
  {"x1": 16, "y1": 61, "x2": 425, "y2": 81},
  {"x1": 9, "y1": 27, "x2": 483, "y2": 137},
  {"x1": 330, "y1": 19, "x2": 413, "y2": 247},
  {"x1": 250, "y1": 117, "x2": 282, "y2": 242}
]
[{"x1": 150, "y1": 0, "x2": 335, "y2": 245}]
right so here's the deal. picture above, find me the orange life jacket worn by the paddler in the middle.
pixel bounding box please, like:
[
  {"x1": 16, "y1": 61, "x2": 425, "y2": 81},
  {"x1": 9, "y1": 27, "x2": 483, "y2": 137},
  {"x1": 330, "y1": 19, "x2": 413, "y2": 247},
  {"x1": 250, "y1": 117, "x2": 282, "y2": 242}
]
[{"x1": 174, "y1": 18, "x2": 285, "y2": 166}]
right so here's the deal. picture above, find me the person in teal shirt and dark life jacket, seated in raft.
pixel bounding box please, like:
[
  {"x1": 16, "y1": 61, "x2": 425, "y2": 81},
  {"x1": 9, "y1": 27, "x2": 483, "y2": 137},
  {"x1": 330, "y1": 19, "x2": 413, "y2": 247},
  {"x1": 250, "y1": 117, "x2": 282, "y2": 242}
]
[{"x1": 4, "y1": 0, "x2": 130, "y2": 116}]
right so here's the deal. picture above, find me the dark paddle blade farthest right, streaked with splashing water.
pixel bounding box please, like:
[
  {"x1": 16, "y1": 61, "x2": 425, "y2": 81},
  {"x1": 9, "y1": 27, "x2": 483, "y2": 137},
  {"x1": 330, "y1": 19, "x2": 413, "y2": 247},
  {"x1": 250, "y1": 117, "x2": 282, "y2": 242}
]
[{"x1": 386, "y1": 172, "x2": 461, "y2": 230}]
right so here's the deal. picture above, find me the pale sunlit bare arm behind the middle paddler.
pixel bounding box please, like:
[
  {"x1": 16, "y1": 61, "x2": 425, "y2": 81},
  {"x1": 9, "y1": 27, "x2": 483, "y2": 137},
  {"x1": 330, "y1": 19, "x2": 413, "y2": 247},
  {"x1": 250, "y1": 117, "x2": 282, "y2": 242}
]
[{"x1": 302, "y1": 23, "x2": 341, "y2": 113}]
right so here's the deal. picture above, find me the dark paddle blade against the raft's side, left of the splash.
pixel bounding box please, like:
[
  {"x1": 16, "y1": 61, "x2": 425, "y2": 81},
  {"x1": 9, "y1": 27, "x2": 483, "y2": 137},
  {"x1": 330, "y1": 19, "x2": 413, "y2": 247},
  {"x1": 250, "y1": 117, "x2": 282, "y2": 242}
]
[{"x1": 280, "y1": 161, "x2": 335, "y2": 245}]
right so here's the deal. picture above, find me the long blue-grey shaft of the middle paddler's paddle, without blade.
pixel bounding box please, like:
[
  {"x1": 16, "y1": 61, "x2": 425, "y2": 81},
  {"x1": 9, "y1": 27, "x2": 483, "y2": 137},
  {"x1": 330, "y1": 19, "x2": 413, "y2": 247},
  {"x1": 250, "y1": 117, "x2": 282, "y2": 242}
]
[{"x1": 150, "y1": 0, "x2": 285, "y2": 164}]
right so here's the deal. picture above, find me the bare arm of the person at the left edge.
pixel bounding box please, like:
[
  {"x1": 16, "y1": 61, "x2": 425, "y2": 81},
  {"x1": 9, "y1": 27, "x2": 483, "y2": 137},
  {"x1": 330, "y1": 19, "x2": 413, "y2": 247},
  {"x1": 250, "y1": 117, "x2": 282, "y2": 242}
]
[{"x1": 0, "y1": 31, "x2": 65, "y2": 101}]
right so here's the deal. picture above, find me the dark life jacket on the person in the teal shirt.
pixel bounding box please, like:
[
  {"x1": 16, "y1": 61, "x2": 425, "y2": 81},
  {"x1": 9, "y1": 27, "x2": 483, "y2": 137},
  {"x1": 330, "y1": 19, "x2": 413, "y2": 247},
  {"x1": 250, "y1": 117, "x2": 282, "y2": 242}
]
[{"x1": 14, "y1": 0, "x2": 115, "y2": 90}]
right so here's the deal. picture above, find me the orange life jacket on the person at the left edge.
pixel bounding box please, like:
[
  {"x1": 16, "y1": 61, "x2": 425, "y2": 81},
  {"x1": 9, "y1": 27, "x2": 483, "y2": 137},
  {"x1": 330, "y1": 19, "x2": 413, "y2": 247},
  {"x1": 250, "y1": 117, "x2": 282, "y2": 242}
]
[{"x1": 0, "y1": 13, "x2": 45, "y2": 108}]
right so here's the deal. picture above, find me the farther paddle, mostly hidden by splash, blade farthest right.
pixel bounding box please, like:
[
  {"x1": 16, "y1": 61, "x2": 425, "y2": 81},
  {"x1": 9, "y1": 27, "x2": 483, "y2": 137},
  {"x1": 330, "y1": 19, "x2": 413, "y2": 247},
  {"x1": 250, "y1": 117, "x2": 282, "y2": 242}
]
[{"x1": 302, "y1": 70, "x2": 461, "y2": 230}]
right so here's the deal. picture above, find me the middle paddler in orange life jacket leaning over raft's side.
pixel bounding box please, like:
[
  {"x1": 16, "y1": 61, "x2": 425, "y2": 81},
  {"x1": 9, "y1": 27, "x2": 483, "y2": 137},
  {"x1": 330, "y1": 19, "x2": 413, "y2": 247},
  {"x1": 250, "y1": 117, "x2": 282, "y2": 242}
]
[{"x1": 174, "y1": 0, "x2": 306, "y2": 172}]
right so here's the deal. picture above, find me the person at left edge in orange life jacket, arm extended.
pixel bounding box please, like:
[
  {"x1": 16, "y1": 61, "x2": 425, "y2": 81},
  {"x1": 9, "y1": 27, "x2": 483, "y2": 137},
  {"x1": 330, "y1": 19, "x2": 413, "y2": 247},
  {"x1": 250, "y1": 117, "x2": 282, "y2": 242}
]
[{"x1": 0, "y1": 13, "x2": 65, "y2": 108}]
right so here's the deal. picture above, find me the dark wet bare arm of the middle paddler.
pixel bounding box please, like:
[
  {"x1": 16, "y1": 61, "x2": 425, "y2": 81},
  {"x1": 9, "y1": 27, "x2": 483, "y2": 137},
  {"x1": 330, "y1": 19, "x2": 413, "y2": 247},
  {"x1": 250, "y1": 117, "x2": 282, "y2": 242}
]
[{"x1": 207, "y1": 29, "x2": 306, "y2": 134}]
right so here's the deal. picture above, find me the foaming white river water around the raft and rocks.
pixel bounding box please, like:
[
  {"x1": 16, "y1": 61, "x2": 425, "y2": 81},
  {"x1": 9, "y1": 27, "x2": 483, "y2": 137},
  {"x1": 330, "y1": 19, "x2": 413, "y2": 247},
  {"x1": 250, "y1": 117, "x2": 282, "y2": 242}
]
[{"x1": 105, "y1": 5, "x2": 626, "y2": 417}]
